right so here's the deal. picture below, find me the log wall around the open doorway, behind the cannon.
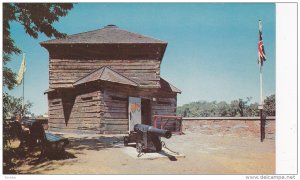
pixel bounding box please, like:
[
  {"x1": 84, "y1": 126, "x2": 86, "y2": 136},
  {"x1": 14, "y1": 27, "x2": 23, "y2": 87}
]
[{"x1": 101, "y1": 83, "x2": 177, "y2": 133}]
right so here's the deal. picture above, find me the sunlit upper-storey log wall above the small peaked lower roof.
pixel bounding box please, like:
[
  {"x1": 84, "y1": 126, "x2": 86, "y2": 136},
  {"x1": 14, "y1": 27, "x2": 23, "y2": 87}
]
[{"x1": 49, "y1": 59, "x2": 160, "y2": 88}]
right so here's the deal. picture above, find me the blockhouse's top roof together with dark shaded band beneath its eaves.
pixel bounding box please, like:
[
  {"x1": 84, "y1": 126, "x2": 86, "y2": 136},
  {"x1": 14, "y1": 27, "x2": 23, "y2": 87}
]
[{"x1": 40, "y1": 25, "x2": 167, "y2": 61}]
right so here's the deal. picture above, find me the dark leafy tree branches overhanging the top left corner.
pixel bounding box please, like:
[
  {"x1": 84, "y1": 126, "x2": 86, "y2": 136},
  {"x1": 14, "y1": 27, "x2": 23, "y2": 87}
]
[{"x1": 3, "y1": 3, "x2": 73, "y2": 89}]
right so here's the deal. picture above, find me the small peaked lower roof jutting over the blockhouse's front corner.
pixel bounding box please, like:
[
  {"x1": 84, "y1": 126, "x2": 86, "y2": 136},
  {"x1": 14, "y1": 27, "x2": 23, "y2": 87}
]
[{"x1": 73, "y1": 66, "x2": 138, "y2": 86}]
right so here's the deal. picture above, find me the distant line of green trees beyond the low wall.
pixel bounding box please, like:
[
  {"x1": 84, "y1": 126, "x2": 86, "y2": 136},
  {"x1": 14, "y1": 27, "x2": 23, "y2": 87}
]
[{"x1": 177, "y1": 94, "x2": 276, "y2": 117}]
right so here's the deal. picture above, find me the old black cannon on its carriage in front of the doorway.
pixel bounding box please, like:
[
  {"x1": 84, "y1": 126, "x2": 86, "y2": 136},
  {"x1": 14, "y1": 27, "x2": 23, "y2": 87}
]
[{"x1": 124, "y1": 124, "x2": 172, "y2": 154}]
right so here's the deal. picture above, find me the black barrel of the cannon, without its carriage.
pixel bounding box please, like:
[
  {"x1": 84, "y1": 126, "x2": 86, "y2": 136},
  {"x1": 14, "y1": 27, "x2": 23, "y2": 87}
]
[{"x1": 134, "y1": 124, "x2": 172, "y2": 139}]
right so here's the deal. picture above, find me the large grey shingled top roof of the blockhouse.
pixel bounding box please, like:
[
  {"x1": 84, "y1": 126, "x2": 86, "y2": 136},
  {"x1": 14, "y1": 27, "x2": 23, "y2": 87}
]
[{"x1": 41, "y1": 25, "x2": 166, "y2": 45}]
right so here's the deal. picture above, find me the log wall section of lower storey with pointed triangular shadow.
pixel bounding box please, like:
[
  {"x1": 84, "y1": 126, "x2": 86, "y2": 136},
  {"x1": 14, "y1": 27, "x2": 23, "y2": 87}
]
[{"x1": 48, "y1": 89, "x2": 104, "y2": 133}]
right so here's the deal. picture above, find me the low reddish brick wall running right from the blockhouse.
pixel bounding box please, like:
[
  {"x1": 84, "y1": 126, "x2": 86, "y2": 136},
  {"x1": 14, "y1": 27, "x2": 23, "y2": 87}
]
[{"x1": 182, "y1": 117, "x2": 275, "y2": 139}]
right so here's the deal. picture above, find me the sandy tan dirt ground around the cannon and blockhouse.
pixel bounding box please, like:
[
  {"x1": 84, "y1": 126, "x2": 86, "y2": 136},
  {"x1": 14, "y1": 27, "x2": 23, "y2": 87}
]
[{"x1": 13, "y1": 131, "x2": 275, "y2": 174}]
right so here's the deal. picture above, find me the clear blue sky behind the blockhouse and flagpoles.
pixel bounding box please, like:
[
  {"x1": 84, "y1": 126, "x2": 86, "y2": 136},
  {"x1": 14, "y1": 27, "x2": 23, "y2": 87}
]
[{"x1": 3, "y1": 3, "x2": 276, "y2": 115}]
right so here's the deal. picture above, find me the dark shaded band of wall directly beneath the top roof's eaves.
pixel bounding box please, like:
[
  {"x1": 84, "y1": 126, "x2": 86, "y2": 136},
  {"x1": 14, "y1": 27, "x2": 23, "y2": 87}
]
[{"x1": 42, "y1": 43, "x2": 167, "y2": 61}]
